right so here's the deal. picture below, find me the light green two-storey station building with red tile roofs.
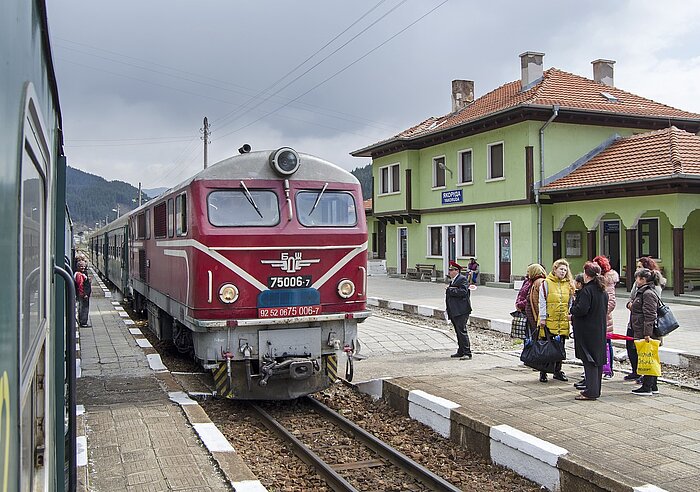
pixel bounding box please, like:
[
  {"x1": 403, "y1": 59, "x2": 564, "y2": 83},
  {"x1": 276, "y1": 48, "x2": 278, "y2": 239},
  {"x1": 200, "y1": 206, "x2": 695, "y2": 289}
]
[{"x1": 352, "y1": 52, "x2": 700, "y2": 295}]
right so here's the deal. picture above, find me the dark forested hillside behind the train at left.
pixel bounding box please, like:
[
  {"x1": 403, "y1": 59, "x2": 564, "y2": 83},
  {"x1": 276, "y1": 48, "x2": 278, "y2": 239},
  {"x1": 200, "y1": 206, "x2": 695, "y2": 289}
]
[{"x1": 66, "y1": 166, "x2": 148, "y2": 233}]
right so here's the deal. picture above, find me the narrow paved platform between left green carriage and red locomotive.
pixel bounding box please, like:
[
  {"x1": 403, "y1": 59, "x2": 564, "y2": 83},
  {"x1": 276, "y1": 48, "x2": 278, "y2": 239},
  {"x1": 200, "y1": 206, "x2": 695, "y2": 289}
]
[{"x1": 77, "y1": 272, "x2": 265, "y2": 492}]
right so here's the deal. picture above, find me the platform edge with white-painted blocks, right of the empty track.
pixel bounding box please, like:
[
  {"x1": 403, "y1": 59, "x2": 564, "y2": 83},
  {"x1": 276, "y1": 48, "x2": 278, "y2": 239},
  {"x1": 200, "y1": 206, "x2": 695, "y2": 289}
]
[{"x1": 349, "y1": 379, "x2": 664, "y2": 492}]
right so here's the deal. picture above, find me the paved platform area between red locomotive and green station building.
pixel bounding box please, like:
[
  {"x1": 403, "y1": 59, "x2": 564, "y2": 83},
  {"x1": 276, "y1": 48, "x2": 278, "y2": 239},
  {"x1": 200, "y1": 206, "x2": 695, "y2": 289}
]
[{"x1": 355, "y1": 277, "x2": 700, "y2": 491}]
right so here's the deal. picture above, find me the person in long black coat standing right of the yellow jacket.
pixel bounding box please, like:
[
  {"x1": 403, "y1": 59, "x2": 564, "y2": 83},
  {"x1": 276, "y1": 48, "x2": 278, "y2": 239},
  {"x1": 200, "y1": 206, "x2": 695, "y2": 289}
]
[{"x1": 571, "y1": 261, "x2": 608, "y2": 400}]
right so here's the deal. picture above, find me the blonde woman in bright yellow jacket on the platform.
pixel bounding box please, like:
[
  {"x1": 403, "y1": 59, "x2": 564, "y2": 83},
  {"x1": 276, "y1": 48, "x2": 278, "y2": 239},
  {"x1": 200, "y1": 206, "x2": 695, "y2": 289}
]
[{"x1": 539, "y1": 259, "x2": 574, "y2": 383}]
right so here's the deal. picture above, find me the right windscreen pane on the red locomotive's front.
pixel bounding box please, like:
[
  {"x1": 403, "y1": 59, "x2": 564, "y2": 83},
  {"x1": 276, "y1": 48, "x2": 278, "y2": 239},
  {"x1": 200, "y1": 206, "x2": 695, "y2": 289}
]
[{"x1": 296, "y1": 190, "x2": 357, "y2": 227}]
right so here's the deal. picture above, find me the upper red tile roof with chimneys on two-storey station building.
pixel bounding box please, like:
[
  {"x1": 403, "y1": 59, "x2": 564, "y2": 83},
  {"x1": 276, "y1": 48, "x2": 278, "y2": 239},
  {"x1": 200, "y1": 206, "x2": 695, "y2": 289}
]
[{"x1": 360, "y1": 68, "x2": 700, "y2": 147}]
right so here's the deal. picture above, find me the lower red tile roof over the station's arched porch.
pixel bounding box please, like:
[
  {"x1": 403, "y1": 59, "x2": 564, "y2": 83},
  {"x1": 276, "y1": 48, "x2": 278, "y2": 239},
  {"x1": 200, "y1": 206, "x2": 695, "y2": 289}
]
[{"x1": 541, "y1": 126, "x2": 700, "y2": 193}]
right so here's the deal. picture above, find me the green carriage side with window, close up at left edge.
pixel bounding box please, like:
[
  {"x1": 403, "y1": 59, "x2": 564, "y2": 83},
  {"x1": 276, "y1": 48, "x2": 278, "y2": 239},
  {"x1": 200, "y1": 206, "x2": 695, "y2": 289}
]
[{"x1": 0, "y1": 0, "x2": 75, "y2": 491}]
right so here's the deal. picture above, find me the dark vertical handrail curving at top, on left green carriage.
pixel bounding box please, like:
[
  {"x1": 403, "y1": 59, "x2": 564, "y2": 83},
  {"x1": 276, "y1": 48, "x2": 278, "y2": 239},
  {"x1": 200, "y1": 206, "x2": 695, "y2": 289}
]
[{"x1": 53, "y1": 265, "x2": 78, "y2": 490}]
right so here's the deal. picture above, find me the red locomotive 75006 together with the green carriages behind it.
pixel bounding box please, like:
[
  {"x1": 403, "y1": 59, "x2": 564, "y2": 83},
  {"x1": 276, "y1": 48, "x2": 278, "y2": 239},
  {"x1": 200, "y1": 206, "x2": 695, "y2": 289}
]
[{"x1": 90, "y1": 147, "x2": 369, "y2": 399}]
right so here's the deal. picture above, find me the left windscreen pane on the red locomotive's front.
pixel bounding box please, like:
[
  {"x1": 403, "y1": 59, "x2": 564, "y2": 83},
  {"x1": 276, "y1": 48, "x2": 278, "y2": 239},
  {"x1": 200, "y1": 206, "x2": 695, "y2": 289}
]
[{"x1": 207, "y1": 189, "x2": 280, "y2": 227}]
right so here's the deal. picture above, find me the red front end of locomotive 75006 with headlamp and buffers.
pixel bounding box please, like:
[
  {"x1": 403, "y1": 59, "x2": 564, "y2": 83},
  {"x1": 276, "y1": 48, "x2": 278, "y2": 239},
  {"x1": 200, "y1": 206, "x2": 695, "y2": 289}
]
[{"x1": 178, "y1": 148, "x2": 369, "y2": 399}]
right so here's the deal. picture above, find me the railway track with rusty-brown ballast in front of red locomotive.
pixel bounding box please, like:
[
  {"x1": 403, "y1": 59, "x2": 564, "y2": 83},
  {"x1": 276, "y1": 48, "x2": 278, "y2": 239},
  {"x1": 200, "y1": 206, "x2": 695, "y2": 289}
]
[{"x1": 250, "y1": 397, "x2": 461, "y2": 492}]
